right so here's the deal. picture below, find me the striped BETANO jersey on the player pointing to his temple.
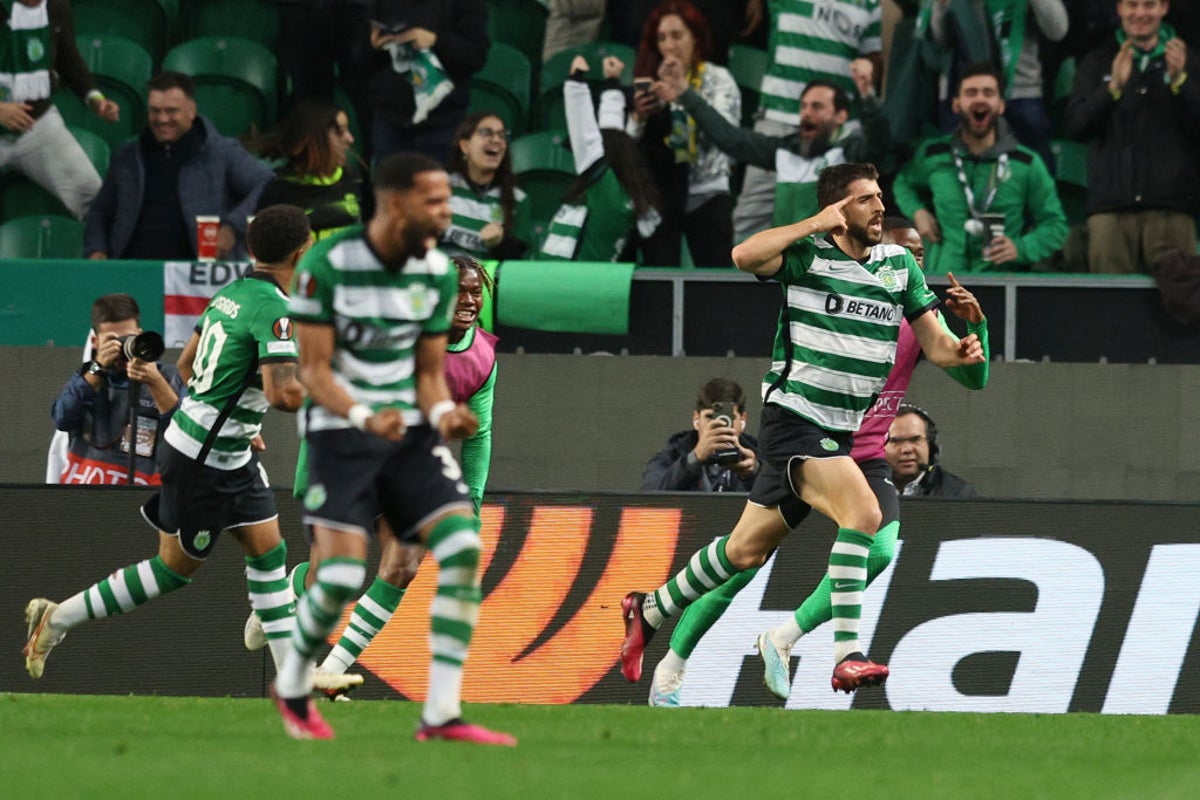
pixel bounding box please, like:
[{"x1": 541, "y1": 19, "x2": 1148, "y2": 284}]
[{"x1": 762, "y1": 237, "x2": 937, "y2": 431}]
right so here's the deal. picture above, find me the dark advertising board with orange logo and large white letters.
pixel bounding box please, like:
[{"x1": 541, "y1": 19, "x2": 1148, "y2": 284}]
[{"x1": 9, "y1": 487, "x2": 1200, "y2": 714}]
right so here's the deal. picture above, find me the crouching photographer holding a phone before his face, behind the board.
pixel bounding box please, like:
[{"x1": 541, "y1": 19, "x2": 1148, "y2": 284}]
[{"x1": 642, "y1": 378, "x2": 758, "y2": 492}]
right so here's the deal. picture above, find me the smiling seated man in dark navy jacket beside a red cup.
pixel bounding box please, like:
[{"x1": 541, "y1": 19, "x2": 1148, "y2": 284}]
[{"x1": 84, "y1": 72, "x2": 271, "y2": 259}]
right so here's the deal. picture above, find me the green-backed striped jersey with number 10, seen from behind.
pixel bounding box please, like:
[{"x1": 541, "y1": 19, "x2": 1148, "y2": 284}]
[{"x1": 163, "y1": 272, "x2": 298, "y2": 470}]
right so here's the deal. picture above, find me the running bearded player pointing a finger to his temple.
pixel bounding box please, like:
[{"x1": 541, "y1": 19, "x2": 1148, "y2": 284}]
[{"x1": 620, "y1": 163, "x2": 984, "y2": 697}]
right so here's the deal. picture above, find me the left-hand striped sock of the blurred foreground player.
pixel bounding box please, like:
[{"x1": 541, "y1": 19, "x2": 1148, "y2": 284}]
[{"x1": 275, "y1": 558, "x2": 367, "y2": 698}]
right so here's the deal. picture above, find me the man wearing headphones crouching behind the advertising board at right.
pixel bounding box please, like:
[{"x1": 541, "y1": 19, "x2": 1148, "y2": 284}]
[{"x1": 884, "y1": 403, "x2": 977, "y2": 498}]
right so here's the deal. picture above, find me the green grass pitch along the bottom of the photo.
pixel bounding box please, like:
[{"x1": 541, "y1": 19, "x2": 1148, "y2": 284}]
[{"x1": 0, "y1": 693, "x2": 1200, "y2": 800}]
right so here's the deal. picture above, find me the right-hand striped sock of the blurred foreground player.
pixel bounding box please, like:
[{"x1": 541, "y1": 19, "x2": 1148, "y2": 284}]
[{"x1": 421, "y1": 516, "x2": 480, "y2": 726}]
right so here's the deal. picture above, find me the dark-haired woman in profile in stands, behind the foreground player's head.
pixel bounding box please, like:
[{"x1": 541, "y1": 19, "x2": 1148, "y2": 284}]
[{"x1": 254, "y1": 100, "x2": 362, "y2": 240}]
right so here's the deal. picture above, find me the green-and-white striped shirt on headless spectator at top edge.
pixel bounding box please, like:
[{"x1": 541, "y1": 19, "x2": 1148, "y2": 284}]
[{"x1": 758, "y1": 0, "x2": 883, "y2": 126}]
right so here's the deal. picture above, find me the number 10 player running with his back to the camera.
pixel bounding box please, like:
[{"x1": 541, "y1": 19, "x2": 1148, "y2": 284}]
[{"x1": 24, "y1": 206, "x2": 343, "y2": 695}]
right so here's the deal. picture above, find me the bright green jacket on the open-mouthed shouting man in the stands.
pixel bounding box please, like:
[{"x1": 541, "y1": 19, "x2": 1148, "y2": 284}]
[{"x1": 893, "y1": 119, "x2": 1067, "y2": 272}]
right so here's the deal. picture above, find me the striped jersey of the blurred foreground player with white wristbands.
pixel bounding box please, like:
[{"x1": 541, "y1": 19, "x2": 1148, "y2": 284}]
[{"x1": 289, "y1": 225, "x2": 458, "y2": 431}]
